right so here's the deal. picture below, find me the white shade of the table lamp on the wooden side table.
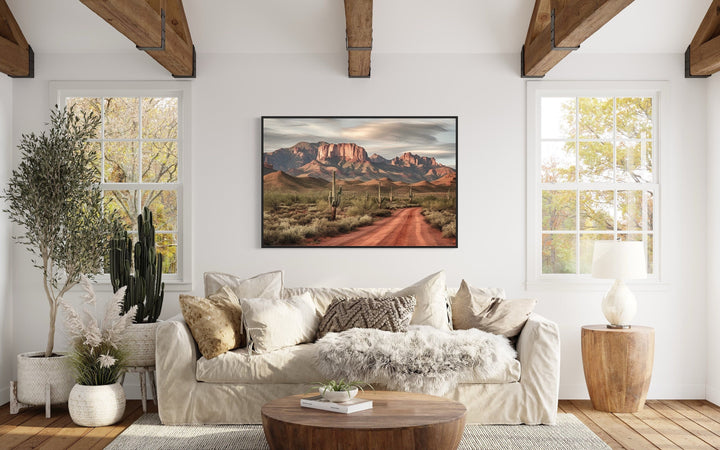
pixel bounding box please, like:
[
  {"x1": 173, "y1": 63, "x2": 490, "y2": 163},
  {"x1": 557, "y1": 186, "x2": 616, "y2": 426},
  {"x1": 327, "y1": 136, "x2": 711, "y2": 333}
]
[{"x1": 592, "y1": 241, "x2": 647, "y2": 280}]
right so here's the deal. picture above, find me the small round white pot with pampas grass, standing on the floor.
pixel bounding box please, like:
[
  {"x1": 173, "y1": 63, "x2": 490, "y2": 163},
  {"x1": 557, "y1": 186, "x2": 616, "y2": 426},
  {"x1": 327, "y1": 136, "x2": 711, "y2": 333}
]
[{"x1": 68, "y1": 383, "x2": 125, "y2": 427}]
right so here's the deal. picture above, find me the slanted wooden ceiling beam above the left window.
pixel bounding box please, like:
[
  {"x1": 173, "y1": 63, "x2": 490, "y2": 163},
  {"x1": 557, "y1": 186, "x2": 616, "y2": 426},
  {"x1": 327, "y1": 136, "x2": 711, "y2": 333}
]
[{"x1": 80, "y1": 0, "x2": 195, "y2": 78}]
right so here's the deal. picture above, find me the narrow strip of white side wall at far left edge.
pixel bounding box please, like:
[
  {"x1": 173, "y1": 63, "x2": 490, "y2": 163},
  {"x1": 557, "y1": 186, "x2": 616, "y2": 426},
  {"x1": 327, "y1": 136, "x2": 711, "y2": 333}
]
[{"x1": 0, "y1": 75, "x2": 15, "y2": 404}]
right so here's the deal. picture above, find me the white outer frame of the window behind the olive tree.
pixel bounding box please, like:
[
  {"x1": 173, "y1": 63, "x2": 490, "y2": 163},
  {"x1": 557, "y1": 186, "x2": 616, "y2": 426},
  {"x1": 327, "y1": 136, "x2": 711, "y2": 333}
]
[{"x1": 49, "y1": 81, "x2": 192, "y2": 291}]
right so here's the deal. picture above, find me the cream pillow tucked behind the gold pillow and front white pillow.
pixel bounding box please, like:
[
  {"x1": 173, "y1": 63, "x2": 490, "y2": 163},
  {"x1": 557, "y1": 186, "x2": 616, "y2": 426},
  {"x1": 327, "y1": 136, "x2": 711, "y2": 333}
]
[{"x1": 204, "y1": 270, "x2": 283, "y2": 298}]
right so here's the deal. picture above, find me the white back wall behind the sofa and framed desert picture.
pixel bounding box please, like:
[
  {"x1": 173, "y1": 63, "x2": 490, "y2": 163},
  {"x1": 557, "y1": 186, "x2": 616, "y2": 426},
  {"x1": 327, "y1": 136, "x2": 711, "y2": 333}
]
[{"x1": 14, "y1": 53, "x2": 707, "y2": 398}]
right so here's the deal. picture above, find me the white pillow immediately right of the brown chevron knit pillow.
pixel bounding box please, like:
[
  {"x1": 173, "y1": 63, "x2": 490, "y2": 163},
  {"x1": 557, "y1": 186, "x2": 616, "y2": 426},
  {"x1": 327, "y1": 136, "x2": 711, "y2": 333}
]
[{"x1": 393, "y1": 270, "x2": 450, "y2": 330}]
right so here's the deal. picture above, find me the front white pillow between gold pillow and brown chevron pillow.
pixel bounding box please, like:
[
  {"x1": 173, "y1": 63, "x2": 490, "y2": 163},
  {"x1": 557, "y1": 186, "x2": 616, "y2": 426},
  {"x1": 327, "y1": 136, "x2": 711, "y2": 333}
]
[{"x1": 240, "y1": 293, "x2": 320, "y2": 353}]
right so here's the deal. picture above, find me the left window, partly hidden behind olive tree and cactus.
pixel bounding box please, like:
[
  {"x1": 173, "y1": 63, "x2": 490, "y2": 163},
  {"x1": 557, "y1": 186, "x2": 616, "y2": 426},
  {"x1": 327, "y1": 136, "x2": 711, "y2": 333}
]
[{"x1": 52, "y1": 81, "x2": 189, "y2": 282}]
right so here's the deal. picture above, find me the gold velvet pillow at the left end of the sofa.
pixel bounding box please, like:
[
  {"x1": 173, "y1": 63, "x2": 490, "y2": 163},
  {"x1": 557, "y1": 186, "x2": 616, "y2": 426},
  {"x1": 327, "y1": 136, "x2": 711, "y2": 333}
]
[{"x1": 180, "y1": 286, "x2": 245, "y2": 359}]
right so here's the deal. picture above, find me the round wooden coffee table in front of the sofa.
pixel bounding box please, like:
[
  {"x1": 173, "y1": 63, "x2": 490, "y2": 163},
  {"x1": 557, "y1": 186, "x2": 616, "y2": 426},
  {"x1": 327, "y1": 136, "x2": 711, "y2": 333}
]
[{"x1": 262, "y1": 391, "x2": 467, "y2": 450}]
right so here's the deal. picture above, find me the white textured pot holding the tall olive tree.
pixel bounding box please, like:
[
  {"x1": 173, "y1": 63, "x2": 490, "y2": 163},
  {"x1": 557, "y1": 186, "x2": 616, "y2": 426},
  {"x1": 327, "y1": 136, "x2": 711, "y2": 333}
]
[{"x1": 17, "y1": 352, "x2": 75, "y2": 405}]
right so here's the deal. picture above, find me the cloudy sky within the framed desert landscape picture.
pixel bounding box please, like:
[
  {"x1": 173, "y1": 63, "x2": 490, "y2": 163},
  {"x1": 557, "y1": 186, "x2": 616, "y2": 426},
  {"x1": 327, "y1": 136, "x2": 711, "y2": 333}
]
[{"x1": 263, "y1": 117, "x2": 457, "y2": 167}]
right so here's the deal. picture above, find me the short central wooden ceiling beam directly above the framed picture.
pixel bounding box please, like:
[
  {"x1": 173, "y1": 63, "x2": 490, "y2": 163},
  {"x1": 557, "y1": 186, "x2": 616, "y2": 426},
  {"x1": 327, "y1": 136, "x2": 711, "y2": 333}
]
[{"x1": 345, "y1": 0, "x2": 373, "y2": 78}]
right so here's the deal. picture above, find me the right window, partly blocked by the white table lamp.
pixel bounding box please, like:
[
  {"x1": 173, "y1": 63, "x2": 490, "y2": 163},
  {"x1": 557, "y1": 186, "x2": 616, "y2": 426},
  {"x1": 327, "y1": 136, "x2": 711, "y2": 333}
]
[{"x1": 528, "y1": 82, "x2": 659, "y2": 280}]
